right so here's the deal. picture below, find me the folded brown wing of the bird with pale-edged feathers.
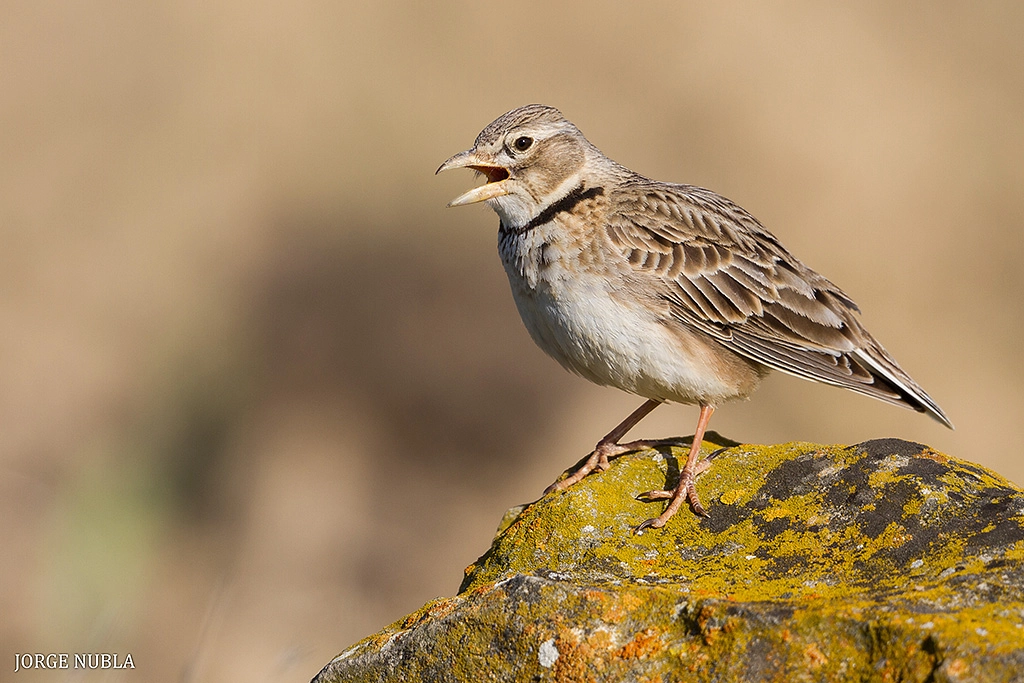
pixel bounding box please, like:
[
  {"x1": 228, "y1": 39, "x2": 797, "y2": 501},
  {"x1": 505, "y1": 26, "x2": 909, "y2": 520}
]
[{"x1": 606, "y1": 176, "x2": 947, "y2": 422}]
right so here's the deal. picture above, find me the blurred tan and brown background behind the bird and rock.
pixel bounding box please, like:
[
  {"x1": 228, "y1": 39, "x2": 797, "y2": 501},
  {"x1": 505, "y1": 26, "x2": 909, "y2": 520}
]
[{"x1": 0, "y1": 0, "x2": 1024, "y2": 681}]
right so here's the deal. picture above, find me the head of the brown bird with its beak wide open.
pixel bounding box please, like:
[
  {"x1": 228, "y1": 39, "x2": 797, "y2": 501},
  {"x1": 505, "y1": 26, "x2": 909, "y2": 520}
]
[{"x1": 437, "y1": 104, "x2": 600, "y2": 226}]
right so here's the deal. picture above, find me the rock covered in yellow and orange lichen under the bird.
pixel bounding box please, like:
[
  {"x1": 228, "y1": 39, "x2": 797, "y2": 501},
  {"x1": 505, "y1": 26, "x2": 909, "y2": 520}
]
[{"x1": 314, "y1": 434, "x2": 1024, "y2": 683}]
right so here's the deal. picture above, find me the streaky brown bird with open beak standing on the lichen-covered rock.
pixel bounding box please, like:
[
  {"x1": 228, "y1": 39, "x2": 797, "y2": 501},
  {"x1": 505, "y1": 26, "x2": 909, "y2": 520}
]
[{"x1": 435, "y1": 104, "x2": 953, "y2": 533}]
